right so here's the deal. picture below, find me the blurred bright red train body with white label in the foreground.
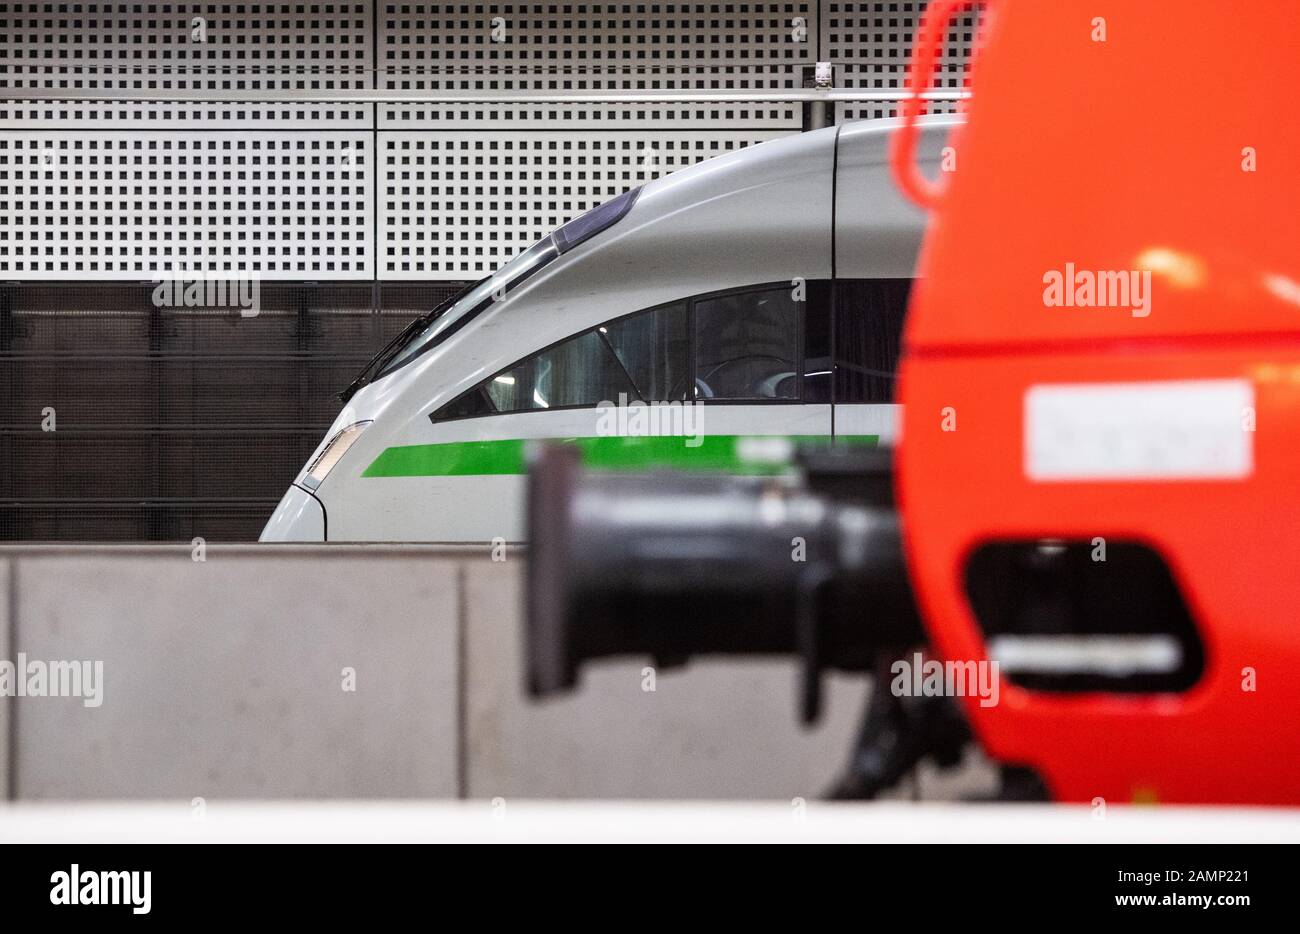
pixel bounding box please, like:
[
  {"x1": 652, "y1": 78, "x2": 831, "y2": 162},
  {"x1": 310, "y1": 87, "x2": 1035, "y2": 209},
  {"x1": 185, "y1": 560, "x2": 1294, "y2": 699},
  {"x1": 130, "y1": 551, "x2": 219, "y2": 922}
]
[{"x1": 896, "y1": 0, "x2": 1300, "y2": 804}]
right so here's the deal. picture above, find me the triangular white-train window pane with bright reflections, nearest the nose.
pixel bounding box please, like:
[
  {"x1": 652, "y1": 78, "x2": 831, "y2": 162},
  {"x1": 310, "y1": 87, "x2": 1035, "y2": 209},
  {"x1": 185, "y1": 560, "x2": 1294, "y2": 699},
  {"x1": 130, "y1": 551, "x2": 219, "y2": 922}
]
[{"x1": 486, "y1": 330, "x2": 636, "y2": 412}]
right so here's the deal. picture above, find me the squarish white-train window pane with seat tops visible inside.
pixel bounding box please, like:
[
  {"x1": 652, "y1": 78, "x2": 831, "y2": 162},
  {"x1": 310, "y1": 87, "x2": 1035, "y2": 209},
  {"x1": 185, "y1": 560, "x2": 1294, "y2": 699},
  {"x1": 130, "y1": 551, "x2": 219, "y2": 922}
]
[{"x1": 694, "y1": 285, "x2": 803, "y2": 401}]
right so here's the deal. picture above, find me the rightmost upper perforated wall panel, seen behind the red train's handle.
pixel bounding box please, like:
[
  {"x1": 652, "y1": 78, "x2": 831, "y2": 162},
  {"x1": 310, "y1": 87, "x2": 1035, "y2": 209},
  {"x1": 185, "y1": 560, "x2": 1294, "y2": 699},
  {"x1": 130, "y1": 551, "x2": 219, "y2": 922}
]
[{"x1": 820, "y1": 0, "x2": 980, "y2": 122}]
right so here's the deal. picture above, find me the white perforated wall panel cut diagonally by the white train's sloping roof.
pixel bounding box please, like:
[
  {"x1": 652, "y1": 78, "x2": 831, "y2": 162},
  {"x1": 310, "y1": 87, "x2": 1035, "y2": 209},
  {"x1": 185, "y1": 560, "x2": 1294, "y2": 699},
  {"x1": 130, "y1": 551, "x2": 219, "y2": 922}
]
[{"x1": 380, "y1": 130, "x2": 785, "y2": 280}]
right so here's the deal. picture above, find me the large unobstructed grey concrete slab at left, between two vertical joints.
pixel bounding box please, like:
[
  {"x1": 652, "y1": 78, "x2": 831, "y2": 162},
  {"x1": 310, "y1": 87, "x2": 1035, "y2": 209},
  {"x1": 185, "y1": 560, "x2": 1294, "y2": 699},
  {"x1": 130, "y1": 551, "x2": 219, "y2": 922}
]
[{"x1": 7, "y1": 546, "x2": 459, "y2": 800}]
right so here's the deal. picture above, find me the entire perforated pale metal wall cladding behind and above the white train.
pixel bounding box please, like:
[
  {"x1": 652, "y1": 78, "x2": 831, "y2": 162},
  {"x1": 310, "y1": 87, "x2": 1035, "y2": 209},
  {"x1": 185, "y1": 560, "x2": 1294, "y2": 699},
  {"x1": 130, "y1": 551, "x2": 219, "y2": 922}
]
[{"x1": 0, "y1": 0, "x2": 976, "y2": 281}]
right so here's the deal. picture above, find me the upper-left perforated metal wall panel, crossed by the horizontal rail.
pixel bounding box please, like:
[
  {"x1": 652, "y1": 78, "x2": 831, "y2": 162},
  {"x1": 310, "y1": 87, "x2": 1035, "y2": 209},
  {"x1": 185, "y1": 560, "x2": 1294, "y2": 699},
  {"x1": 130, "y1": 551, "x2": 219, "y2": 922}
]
[{"x1": 0, "y1": 1, "x2": 373, "y2": 129}]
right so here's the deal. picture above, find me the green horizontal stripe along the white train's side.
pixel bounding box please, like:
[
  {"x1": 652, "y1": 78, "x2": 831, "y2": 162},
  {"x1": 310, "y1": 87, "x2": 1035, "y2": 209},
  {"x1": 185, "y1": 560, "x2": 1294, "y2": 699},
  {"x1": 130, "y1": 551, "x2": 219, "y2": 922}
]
[{"x1": 361, "y1": 434, "x2": 879, "y2": 476}]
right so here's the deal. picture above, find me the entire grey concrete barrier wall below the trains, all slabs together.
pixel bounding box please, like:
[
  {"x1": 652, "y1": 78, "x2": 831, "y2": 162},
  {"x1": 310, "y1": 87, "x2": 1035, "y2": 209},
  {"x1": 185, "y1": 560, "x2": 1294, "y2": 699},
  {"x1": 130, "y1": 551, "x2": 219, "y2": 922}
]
[{"x1": 0, "y1": 545, "x2": 987, "y2": 807}]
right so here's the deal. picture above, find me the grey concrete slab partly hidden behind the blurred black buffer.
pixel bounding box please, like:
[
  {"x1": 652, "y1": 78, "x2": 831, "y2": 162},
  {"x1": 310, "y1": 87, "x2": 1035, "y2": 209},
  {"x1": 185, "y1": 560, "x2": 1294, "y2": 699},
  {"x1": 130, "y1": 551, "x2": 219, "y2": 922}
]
[{"x1": 465, "y1": 561, "x2": 866, "y2": 800}]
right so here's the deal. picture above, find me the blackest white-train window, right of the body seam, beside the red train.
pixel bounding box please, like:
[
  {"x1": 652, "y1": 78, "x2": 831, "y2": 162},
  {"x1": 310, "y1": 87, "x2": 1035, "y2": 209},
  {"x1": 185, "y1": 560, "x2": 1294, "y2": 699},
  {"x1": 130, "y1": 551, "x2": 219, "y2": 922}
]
[{"x1": 835, "y1": 278, "x2": 911, "y2": 403}]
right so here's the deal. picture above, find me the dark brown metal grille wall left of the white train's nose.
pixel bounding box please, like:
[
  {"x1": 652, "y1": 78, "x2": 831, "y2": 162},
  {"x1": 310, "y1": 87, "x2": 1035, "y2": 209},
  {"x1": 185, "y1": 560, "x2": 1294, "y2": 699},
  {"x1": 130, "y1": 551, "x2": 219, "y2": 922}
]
[{"x1": 0, "y1": 282, "x2": 459, "y2": 541}]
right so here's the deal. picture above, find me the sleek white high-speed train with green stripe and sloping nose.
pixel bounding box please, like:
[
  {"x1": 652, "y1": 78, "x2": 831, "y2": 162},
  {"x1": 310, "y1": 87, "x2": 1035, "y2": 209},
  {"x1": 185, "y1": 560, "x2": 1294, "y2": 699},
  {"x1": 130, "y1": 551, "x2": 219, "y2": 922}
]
[{"x1": 261, "y1": 117, "x2": 959, "y2": 541}]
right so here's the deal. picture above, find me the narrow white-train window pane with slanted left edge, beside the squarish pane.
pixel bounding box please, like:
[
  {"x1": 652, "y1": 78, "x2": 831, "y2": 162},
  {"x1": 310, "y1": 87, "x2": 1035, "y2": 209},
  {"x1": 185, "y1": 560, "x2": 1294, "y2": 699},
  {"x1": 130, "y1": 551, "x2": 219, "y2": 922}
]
[{"x1": 598, "y1": 302, "x2": 690, "y2": 402}]
